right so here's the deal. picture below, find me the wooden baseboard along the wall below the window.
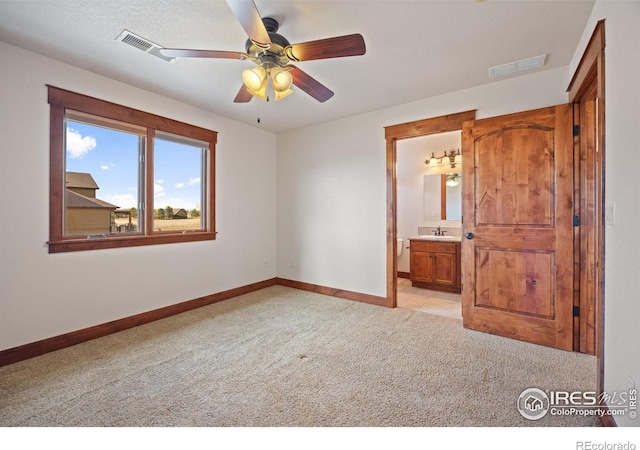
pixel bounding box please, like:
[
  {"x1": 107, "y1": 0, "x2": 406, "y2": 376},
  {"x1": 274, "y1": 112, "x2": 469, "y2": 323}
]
[{"x1": 0, "y1": 278, "x2": 277, "y2": 367}]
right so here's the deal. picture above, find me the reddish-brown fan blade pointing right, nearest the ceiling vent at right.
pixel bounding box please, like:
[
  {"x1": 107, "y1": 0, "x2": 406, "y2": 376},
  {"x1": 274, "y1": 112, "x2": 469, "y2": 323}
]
[{"x1": 284, "y1": 34, "x2": 367, "y2": 61}]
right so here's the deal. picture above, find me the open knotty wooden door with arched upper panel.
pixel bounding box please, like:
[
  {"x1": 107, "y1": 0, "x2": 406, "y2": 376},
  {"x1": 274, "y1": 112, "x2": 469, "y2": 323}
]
[{"x1": 462, "y1": 105, "x2": 573, "y2": 350}]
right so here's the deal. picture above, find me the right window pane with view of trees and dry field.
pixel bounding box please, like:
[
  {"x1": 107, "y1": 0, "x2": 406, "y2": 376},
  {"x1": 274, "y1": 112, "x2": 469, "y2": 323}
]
[{"x1": 153, "y1": 133, "x2": 208, "y2": 232}]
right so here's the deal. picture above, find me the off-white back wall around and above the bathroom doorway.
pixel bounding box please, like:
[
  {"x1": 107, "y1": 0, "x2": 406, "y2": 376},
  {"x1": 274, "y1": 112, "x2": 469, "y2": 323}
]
[{"x1": 278, "y1": 67, "x2": 569, "y2": 297}]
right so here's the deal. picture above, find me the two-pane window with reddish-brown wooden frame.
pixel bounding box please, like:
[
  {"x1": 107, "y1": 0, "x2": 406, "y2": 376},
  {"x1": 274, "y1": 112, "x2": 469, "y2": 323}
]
[{"x1": 48, "y1": 86, "x2": 217, "y2": 253}]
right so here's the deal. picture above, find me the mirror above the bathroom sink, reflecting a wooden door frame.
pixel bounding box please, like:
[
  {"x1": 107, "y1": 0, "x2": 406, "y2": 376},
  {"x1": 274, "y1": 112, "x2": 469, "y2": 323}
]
[{"x1": 423, "y1": 173, "x2": 462, "y2": 221}]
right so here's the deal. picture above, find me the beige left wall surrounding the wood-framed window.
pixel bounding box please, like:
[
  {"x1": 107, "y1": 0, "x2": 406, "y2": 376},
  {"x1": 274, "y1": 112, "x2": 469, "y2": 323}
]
[{"x1": 0, "y1": 42, "x2": 276, "y2": 350}]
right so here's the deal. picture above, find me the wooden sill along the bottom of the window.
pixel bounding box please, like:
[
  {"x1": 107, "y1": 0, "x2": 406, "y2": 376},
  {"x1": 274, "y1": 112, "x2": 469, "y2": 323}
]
[{"x1": 47, "y1": 231, "x2": 217, "y2": 253}]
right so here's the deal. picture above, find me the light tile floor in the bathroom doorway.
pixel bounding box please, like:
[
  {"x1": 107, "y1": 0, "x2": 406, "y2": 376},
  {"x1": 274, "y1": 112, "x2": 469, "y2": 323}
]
[{"x1": 398, "y1": 278, "x2": 462, "y2": 319}]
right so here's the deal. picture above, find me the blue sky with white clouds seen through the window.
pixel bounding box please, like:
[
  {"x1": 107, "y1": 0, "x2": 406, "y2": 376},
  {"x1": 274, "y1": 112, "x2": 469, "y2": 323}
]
[{"x1": 66, "y1": 121, "x2": 201, "y2": 210}]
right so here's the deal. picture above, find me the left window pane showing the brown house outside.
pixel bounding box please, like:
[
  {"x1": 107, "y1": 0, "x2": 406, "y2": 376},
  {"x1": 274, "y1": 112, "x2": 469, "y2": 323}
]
[{"x1": 64, "y1": 120, "x2": 144, "y2": 237}]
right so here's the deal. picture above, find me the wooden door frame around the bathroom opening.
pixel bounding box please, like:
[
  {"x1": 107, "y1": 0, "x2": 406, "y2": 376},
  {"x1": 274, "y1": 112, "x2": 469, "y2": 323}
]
[{"x1": 384, "y1": 109, "x2": 476, "y2": 308}]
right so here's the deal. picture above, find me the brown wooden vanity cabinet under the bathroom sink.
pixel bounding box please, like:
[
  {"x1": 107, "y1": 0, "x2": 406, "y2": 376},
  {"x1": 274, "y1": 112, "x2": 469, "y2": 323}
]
[{"x1": 409, "y1": 239, "x2": 461, "y2": 292}]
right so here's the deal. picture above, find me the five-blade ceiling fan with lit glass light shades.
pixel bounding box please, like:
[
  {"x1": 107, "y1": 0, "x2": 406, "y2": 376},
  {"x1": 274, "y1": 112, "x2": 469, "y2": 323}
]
[{"x1": 159, "y1": 0, "x2": 366, "y2": 103}]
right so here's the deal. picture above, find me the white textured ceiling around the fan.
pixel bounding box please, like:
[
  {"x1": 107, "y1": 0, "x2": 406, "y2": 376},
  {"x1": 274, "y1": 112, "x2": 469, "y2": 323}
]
[{"x1": 0, "y1": 0, "x2": 593, "y2": 132}]
